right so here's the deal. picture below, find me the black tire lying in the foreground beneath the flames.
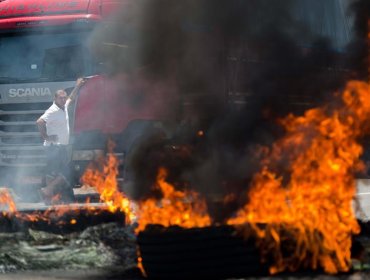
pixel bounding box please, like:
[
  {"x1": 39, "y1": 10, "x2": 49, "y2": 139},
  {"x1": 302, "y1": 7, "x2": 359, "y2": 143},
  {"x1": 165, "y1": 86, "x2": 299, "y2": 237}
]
[{"x1": 138, "y1": 225, "x2": 268, "y2": 279}]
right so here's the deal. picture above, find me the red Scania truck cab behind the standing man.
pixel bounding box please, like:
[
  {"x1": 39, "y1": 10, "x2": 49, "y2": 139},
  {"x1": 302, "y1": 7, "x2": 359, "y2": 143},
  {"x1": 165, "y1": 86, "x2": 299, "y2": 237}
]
[{"x1": 0, "y1": 0, "x2": 182, "y2": 199}]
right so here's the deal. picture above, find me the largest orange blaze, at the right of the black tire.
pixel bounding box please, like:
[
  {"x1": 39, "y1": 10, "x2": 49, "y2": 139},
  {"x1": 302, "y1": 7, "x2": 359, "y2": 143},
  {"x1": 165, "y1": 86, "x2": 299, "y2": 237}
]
[{"x1": 228, "y1": 81, "x2": 370, "y2": 273}]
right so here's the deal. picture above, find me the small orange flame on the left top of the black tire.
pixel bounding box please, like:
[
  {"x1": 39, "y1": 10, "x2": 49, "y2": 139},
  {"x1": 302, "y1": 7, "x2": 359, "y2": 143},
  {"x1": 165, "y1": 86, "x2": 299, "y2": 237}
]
[{"x1": 136, "y1": 168, "x2": 211, "y2": 232}]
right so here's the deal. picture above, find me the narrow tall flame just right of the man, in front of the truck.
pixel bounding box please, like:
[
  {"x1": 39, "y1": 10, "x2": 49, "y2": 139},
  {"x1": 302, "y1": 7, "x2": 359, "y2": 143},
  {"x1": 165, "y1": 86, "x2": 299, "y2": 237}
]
[{"x1": 81, "y1": 141, "x2": 135, "y2": 222}]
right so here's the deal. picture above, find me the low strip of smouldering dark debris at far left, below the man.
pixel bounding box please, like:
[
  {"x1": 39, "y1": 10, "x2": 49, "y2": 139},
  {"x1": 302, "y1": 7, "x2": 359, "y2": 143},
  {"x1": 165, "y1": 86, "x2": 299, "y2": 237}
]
[{"x1": 0, "y1": 184, "x2": 125, "y2": 233}]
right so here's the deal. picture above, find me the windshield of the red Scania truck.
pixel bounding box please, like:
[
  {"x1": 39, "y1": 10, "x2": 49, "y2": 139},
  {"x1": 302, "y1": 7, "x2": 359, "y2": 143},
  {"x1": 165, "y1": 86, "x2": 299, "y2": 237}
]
[{"x1": 0, "y1": 32, "x2": 91, "y2": 83}]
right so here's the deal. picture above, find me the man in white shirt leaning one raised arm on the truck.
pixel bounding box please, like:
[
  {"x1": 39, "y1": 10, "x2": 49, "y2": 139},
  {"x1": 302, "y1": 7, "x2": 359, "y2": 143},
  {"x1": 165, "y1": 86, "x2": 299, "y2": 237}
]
[{"x1": 36, "y1": 78, "x2": 85, "y2": 204}]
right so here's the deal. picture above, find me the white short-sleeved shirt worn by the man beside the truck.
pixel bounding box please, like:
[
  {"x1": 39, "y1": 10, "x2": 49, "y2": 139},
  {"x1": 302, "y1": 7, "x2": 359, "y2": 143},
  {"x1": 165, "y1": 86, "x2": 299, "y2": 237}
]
[{"x1": 40, "y1": 102, "x2": 69, "y2": 146}]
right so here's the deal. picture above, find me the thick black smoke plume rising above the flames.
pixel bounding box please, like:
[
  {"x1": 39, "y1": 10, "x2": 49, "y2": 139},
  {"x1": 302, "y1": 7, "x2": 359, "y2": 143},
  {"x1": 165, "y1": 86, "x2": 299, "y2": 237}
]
[{"x1": 88, "y1": 0, "x2": 369, "y2": 223}]
